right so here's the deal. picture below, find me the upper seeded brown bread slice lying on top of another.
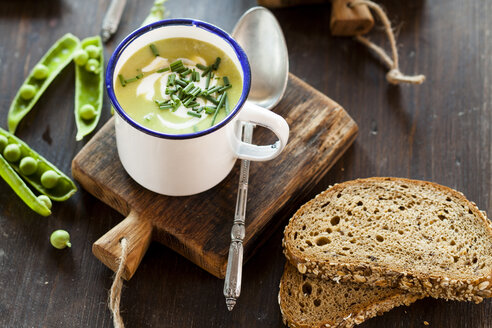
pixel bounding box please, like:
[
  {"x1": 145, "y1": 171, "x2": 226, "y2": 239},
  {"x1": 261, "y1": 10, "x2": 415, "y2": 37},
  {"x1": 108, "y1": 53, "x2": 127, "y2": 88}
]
[{"x1": 283, "y1": 178, "x2": 492, "y2": 303}]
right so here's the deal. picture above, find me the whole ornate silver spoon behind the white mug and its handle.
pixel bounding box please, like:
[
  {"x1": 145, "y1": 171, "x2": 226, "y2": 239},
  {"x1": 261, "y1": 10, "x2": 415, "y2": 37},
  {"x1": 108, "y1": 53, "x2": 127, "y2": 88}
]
[{"x1": 224, "y1": 7, "x2": 289, "y2": 311}]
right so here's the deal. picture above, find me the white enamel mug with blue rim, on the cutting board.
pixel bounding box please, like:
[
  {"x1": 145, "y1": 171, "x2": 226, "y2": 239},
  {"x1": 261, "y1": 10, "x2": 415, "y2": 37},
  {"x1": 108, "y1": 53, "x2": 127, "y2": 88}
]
[{"x1": 106, "y1": 19, "x2": 289, "y2": 196}]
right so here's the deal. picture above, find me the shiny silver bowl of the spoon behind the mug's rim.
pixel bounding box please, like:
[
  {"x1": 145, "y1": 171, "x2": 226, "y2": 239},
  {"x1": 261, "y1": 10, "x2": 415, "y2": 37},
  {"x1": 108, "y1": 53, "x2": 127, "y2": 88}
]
[{"x1": 232, "y1": 7, "x2": 289, "y2": 109}]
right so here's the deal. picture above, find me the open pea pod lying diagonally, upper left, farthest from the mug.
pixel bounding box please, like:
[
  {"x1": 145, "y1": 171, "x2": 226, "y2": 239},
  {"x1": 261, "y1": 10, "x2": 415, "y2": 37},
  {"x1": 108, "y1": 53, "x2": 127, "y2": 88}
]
[{"x1": 7, "y1": 33, "x2": 80, "y2": 133}]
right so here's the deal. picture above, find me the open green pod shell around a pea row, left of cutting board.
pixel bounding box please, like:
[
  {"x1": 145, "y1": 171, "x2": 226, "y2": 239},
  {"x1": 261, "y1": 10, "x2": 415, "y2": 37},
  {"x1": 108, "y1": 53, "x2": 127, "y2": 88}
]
[{"x1": 0, "y1": 128, "x2": 77, "y2": 201}]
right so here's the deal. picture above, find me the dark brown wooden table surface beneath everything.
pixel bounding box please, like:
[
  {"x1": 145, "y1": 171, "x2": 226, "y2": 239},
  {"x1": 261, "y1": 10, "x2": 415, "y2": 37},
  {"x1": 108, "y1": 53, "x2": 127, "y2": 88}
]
[{"x1": 0, "y1": 0, "x2": 492, "y2": 328}]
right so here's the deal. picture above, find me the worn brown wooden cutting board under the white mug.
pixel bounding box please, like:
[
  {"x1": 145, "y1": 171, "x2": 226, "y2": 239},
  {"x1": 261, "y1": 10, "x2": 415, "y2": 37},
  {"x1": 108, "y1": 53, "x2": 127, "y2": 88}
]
[{"x1": 72, "y1": 74, "x2": 358, "y2": 280}]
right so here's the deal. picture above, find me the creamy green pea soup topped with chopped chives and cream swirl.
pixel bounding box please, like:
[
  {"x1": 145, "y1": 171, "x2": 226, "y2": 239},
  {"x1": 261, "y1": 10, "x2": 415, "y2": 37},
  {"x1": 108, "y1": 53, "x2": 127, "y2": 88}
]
[{"x1": 114, "y1": 38, "x2": 242, "y2": 134}]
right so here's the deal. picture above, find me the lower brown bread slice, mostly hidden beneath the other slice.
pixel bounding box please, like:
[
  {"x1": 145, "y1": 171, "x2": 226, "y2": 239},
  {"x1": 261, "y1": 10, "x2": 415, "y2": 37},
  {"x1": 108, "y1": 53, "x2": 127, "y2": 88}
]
[{"x1": 278, "y1": 264, "x2": 421, "y2": 328}]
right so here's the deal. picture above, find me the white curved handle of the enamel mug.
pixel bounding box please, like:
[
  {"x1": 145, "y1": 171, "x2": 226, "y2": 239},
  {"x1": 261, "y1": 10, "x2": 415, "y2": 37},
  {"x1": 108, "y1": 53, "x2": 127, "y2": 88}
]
[{"x1": 236, "y1": 101, "x2": 289, "y2": 162}]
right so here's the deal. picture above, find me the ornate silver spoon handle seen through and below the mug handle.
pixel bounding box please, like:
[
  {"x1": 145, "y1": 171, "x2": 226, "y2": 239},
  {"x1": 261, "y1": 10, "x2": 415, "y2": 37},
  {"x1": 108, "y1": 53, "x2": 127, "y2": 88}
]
[{"x1": 224, "y1": 123, "x2": 254, "y2": 311}]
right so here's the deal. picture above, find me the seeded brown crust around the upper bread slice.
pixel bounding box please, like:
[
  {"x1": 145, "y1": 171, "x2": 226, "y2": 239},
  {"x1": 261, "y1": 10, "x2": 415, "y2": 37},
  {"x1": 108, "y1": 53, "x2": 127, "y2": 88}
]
[{"x1": 282, "y1": 177, "x2": 492, "y2": 303}]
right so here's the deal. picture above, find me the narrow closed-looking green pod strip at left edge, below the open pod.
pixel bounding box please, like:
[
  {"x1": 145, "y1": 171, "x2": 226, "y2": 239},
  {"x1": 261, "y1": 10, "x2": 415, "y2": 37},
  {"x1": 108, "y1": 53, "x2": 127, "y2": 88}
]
[{"x1": 0, "y1": 150, "x2": 51, "y2": 216}]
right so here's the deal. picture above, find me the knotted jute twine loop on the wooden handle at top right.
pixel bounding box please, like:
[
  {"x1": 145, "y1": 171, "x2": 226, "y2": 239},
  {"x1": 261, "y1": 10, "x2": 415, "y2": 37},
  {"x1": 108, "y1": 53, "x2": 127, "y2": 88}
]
[{"x1": 348, "y1": 0, "x2": 425, "y2": 84}]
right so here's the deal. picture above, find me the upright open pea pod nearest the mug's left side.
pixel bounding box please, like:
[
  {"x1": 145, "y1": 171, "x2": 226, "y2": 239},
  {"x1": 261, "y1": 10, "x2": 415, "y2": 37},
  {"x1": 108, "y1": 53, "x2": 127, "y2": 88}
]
[{"x1": 75, "y1": 36, "x2": 104, "y2": 141}]
